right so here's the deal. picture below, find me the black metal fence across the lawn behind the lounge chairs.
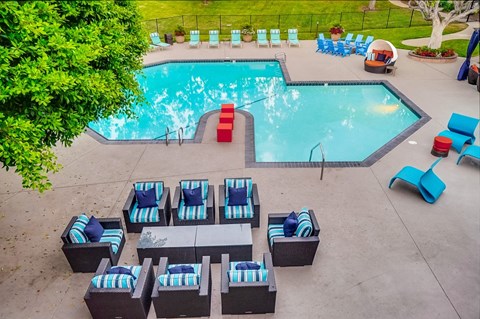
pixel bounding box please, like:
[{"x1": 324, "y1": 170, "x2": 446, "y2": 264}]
[{"x1": 143, "y1": 8, "x2": 430, "y2": 35}]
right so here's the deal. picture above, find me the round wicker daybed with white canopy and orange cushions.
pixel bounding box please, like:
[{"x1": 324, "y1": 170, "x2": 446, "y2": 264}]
[{"x1": 364, "y1": 40, "x2": 398, "y2": 73}]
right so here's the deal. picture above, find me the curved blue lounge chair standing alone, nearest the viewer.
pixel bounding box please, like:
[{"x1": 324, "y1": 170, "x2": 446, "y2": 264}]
[{"x1": 388, "y1": 157, "x2": 446, "y2": 204}]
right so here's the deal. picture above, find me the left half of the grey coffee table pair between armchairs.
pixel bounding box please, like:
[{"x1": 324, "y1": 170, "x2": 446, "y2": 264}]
[{"x1": 137, "y1": 226, "x2": 196, "y2": 265}]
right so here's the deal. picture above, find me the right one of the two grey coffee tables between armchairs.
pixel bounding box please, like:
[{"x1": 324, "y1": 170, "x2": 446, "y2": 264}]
[{"x1": 195, "y1": 224, "x2": 253, "y2": 263}]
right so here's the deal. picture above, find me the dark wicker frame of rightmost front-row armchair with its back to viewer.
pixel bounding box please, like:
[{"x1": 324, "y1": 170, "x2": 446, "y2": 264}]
[{"x1": 220, "y1": 253, "x2": 277, "y2": 314}]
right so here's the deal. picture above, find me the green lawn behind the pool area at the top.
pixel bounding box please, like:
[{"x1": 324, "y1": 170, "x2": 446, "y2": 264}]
[{"x1": 138, "y1": 0, "x2": 472, "y2": 56}]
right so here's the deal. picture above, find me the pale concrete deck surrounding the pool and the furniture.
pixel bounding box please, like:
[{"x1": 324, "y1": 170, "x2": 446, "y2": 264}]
[{"x1": 0, "y1": 41, "x2": 480, "y2": 319}]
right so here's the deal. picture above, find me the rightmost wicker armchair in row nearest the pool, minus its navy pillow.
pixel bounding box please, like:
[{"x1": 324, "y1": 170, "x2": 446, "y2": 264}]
[{"x1": 218, "y1": 177, "x2": 260, "y2": 228}]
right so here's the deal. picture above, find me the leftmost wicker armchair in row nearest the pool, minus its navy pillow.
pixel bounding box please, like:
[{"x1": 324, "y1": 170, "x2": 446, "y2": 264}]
[{"x1": 123, "y1": 181, "x2": 171, "y2": 233}]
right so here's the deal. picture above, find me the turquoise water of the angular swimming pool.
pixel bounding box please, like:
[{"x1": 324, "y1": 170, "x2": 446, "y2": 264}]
[{"x1": 90, "y1": 61, "x2": 419, "y2": 162}]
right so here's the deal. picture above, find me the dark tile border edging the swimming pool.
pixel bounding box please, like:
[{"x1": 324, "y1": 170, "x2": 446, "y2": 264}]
[{"x1": 86, "y1": 58, "x2": 431, "y2": 168}]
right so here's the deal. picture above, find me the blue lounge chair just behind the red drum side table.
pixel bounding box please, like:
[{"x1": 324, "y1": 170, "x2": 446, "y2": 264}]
[{"x1": 438, "y1": 113, "x2": 479, "y2": 153}]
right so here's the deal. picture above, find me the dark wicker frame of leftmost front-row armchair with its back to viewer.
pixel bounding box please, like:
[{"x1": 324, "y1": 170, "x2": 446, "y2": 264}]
[{"x1": 84, "y1": 258, "x2": 155, "y2": 319}]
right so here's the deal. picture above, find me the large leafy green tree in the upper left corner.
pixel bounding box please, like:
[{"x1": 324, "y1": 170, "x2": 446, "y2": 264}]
[{"x1": 0, "y1": 0, "x2": 148, "y2": 191}]
